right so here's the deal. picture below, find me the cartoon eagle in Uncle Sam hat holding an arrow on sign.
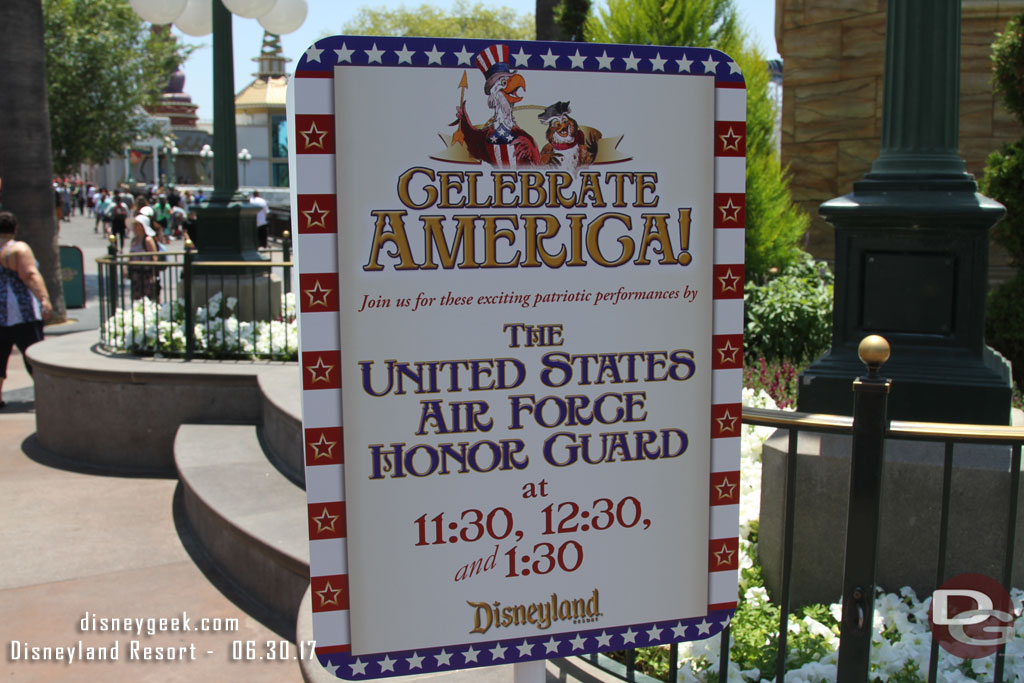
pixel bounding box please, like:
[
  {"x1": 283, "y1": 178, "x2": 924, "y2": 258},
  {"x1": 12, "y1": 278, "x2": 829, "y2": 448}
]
[{"x1": 456, "y1": 45, "x2": 541, "y2": 168}]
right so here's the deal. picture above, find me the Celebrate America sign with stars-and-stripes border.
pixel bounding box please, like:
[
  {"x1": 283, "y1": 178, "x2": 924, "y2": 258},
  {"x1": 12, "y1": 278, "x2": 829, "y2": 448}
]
[{"x1": 291, "y1": 36, "x2": 745, "y2": 680}]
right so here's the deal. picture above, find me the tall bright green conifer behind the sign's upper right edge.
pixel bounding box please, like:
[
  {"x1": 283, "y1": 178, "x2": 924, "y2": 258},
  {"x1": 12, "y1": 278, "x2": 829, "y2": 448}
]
[{"x1": 587, "y1": 0, "x2": 808, "y2": 283}]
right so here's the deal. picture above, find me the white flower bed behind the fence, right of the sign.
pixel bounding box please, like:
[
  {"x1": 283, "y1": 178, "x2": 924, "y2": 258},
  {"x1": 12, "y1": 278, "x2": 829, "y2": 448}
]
[{"x1": 679, "y1": 389, "x2": 1024, "y2": 683}]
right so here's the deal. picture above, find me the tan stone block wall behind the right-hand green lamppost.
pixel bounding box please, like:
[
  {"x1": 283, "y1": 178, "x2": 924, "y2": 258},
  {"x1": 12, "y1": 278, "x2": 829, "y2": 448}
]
[{"x1": 775, "y1": 0, "x2": 1024, "y2": 274}]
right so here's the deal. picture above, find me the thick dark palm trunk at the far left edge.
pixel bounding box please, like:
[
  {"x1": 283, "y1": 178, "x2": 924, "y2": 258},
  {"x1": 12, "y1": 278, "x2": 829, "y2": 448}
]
[{"x1": 0, "y1": 0, "x2": 67, "y2": 322}]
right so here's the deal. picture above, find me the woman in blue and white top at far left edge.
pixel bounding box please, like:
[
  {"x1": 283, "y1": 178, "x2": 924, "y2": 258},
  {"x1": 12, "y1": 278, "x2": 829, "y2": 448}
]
[{"x1": 0, "y1": 211, "x2": 53, "y2": 408}]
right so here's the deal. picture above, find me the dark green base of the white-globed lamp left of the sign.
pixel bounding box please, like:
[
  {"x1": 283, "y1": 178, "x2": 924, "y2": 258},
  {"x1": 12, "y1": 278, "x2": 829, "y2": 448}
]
[{"x1": 195, "y1": 199, "x2": 264, "y2": 261}]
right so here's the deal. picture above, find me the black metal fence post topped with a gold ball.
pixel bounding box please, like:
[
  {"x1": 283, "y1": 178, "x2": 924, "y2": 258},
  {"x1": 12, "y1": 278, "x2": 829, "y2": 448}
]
[{"x1": 837, "y1": 335, "x2": 892, "y2": 683}]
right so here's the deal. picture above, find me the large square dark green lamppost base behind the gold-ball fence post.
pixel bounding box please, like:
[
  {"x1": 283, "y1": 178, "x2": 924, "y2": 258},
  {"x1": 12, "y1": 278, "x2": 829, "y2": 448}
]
[{"x1": 797, "y1": 176, "x2": 1012, "y2": 425}]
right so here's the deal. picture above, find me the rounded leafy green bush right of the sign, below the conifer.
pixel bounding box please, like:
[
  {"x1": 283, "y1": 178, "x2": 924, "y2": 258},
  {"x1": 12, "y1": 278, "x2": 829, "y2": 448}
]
[{"x1": 743, "y1": 254, "x2": 834, "y2": 361}]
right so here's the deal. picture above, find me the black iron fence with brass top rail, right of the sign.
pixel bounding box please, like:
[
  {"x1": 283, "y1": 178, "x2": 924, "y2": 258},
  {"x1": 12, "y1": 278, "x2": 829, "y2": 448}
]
[{"x1": 583, "y1": 338, "x2": 1024, "y2": 683}]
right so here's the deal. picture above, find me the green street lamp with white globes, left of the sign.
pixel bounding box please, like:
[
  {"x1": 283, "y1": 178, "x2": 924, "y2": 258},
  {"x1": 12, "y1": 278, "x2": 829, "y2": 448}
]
[{"x1": 131, "y1": 0, "x2": 307, "y2": 261}]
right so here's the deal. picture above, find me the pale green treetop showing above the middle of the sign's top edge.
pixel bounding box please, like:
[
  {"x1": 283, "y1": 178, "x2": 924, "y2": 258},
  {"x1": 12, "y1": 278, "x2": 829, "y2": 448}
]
[{"x1": 341, "y1": 0, "x2": 534, "y2": 40}]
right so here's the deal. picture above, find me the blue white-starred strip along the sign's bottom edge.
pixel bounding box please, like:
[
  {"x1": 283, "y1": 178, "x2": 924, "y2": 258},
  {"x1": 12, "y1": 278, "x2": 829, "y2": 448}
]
[{"x1": 314, "y1": 609, "x2": 733, "y2": 680}]
